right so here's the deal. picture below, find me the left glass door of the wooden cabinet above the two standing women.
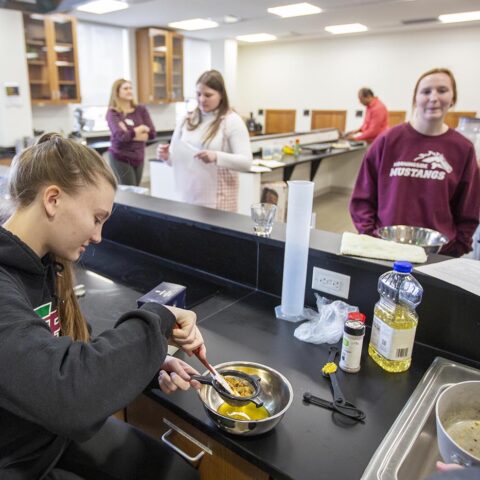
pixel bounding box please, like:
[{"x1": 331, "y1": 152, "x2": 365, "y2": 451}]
[{"x1": 150, "y1": 28, "x2": 170, "y2": 102}]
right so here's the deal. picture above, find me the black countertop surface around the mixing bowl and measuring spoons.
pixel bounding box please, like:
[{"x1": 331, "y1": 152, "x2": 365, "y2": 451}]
[{"x1": 77, "y1": 262, "x2": 479, "y2": 480}]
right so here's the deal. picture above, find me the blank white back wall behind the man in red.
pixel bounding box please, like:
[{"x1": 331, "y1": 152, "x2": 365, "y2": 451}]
[{"x1": 237, "y1": 26, "x2": 480, "y2": 131}]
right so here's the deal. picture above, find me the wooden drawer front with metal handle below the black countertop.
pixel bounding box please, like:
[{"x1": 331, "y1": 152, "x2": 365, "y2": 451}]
[{"x1": 126, "y1": 394, "x2": 270, "y2": 480}]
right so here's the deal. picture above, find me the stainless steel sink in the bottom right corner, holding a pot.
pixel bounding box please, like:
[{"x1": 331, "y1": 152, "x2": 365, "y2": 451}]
[{"x1": 361, "y1": 357, "x2": 480, "y2": 480}]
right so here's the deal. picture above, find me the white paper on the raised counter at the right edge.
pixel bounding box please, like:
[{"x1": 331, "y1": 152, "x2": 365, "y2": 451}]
[{"x1": 415, "y1": 258, "x2": 480, "y2": 295}]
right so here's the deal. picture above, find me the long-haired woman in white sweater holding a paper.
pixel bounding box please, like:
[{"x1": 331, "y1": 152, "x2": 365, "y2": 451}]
[{"x1": 157, "y1": 70, "x2": 252, "y2": 212}]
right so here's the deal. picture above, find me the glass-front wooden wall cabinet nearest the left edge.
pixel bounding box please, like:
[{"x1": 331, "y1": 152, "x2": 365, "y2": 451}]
[{"x1": 23, "y1": 14, "x2": 81, "y2": 105}]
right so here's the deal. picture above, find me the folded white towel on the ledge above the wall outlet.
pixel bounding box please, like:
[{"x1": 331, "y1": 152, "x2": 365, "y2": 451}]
[{"x1": 340, "y1": 232, "x2": 427, "y2": 263}]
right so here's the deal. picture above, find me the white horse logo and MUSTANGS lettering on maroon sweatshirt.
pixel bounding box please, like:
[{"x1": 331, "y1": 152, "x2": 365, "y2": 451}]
[{"x1": 390, "y1": 150, "x2": 453, "y2": 180}]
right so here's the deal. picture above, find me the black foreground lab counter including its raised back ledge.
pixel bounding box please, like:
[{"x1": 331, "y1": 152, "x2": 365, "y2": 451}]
[{"x1": 75, "y1": 192, "x2": 480, "y2": 480}]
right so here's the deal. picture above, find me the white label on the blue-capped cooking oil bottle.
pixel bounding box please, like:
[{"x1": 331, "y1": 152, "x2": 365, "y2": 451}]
[{"x1": 370, "y1": 316, "x2": 417, "y2": 360}]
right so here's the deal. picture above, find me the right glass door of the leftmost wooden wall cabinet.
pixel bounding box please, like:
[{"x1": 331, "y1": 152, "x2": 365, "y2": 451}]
[{"x1": 51, "y1": 15, "x2": 80, "y2": 103}]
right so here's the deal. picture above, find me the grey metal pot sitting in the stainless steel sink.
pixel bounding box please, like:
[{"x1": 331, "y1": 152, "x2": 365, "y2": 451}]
[{"x1": 435, "y1": 381, "x2": 480, "y2": 467}]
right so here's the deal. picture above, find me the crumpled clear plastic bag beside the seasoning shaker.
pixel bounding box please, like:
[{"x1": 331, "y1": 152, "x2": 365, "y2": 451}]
[{"x1": 294, "y1": 293, "x2": 358, "y2": 344}]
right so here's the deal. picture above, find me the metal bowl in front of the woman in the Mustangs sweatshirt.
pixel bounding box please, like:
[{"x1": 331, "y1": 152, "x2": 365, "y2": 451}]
[{"x1": 377, "y1": 225, "x2": 448, "y2": 254}]
